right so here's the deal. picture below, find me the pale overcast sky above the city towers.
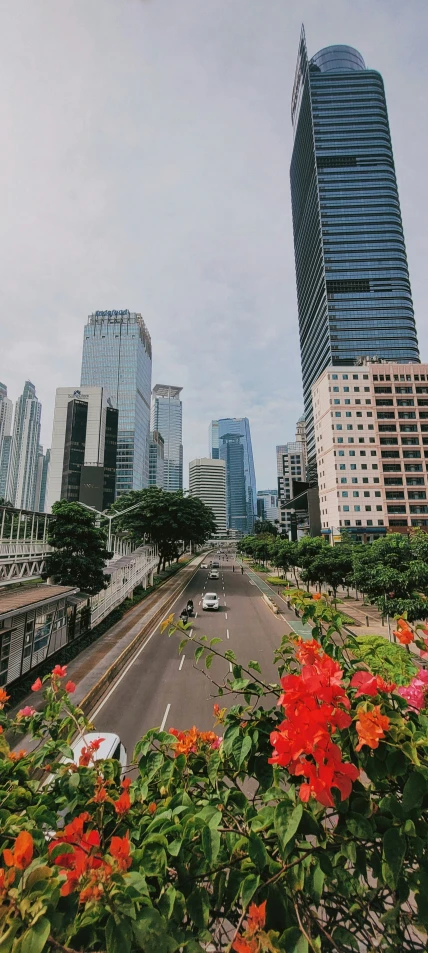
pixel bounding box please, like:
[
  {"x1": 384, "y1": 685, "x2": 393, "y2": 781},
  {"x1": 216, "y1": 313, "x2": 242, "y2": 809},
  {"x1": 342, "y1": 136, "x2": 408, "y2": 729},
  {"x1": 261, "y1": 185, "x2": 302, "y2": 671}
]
[{"x1": 0, "y1": 0, "x2": 428, "y2": 489}]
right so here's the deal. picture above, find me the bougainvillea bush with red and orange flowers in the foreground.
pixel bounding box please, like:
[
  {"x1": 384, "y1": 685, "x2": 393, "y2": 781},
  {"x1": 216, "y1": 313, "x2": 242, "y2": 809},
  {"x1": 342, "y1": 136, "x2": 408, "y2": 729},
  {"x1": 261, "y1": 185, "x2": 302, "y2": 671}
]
[{"x1": 0, "y1": 596, "x2": 428, "y2": 953}]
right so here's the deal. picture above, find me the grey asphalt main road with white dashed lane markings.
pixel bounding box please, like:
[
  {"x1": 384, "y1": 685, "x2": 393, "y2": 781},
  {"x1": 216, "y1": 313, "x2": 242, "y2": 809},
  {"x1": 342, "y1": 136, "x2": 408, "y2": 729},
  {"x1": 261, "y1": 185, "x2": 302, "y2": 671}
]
[{"x1": 91, "y1": 559, "x2": 287, "y2": 758}]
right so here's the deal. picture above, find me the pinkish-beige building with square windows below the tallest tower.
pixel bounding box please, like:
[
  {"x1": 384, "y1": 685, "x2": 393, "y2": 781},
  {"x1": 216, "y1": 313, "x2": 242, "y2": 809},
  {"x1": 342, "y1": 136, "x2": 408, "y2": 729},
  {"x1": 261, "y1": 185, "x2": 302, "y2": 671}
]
[{"x1": 312, "y1": 363, "x2": 428, "y2": 542}]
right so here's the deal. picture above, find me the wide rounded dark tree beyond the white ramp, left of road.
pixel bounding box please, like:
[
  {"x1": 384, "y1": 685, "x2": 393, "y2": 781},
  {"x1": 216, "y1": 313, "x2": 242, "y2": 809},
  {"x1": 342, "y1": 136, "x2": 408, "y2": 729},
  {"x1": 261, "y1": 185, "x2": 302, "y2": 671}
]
[{"x1": 114, "y1": 487, "x2": 216, "y2": 569}]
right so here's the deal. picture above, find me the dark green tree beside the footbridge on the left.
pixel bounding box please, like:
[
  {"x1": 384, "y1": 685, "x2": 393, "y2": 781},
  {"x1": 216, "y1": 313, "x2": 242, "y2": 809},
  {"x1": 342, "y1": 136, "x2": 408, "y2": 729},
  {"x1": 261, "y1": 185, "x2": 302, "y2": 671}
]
[{"x1": 42, "y1": 500, "x2": 112, "y2": 596}]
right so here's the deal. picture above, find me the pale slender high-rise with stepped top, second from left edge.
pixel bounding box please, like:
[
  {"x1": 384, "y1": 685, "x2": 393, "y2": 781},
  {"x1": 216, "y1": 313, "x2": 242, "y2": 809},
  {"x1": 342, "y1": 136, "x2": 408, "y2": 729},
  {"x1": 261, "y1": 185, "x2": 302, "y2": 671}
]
[{"x1": 5, "y1": 381, "x2": 42, "y2": 510}]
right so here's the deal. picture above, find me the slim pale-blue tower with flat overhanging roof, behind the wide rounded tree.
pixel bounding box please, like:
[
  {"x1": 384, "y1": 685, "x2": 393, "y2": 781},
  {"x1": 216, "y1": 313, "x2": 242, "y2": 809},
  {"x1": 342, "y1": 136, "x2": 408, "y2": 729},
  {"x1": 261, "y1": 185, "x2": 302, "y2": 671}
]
[{"x1": 150, "y1": 384, "x2": 183, "y2": 492}]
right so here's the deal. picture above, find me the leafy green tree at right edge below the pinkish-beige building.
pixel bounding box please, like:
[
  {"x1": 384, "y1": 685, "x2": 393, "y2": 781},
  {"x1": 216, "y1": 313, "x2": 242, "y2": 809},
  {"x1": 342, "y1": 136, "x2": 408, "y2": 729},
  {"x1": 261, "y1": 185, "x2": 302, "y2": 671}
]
[{"x1": 353, "y1": 533, "x2": 428, "y2": 621}]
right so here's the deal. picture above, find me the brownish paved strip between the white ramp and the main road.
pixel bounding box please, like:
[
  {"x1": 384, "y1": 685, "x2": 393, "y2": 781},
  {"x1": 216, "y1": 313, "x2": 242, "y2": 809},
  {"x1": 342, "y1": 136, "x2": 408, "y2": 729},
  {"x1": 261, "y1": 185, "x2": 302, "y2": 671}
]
[{"x1": 9, "y1": 556, "x2": 204, "y2": 716}]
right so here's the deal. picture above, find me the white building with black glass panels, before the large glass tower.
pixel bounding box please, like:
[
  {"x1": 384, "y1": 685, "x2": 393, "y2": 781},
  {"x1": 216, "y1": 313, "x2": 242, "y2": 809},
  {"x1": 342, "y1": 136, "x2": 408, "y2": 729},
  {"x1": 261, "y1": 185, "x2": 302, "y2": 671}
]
[{"x1": 46, "y1": 387, "x2": 118, "y2": 513}]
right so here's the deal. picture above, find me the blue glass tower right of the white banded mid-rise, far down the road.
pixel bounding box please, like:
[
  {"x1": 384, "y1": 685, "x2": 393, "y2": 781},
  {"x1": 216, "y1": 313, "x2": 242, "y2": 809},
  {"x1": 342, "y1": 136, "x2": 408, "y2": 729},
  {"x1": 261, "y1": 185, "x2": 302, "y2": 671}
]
[{"x1": 210, "y1": 417, "x2": 257, "y2": 533}]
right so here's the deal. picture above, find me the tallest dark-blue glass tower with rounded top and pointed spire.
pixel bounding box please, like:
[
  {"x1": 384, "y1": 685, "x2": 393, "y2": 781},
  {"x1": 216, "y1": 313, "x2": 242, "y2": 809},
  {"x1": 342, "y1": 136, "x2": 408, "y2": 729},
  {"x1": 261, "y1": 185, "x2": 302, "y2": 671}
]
[{"x1": 290, "y1": 29, "x2": 419, "y2": 463}]
